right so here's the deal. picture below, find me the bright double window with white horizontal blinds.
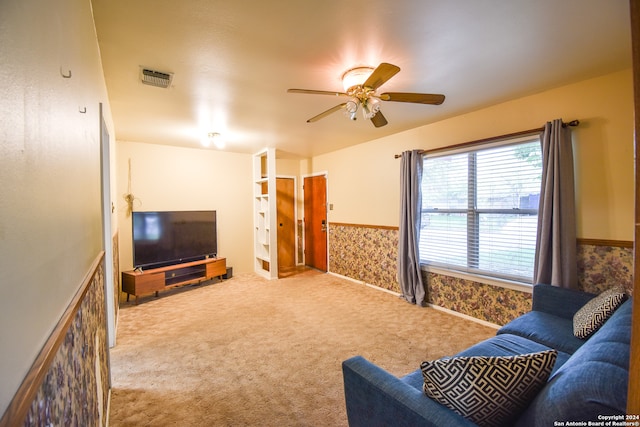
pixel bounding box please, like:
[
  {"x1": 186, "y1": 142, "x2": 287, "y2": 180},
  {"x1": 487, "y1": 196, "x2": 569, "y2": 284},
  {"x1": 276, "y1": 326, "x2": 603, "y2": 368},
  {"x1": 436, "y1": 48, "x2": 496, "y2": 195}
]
[{"x1": 419, "y1": 135, "x2": 542, "y2": 283}]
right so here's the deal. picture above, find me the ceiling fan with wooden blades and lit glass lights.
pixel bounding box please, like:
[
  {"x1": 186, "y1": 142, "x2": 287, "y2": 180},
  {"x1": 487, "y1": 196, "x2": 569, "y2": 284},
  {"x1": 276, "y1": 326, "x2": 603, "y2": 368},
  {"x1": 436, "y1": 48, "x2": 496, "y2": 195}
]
[{"x1": 287, "y1": 62, "x2": 444, "y2": 127}]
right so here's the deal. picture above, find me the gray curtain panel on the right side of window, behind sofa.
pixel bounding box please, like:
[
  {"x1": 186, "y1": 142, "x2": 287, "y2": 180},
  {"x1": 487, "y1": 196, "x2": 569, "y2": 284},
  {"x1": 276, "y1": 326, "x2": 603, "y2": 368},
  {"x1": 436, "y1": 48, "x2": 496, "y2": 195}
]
[{"x1": 533, "y1": 119, "x2": 578, "y2": 288}]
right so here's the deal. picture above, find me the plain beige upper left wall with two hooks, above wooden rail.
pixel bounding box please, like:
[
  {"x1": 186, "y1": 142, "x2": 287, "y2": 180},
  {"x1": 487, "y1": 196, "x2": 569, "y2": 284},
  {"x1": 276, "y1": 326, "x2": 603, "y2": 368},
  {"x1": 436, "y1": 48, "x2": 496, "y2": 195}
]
[{"x1": 0, "y1": 0, "x2": 114, "y2": 413}]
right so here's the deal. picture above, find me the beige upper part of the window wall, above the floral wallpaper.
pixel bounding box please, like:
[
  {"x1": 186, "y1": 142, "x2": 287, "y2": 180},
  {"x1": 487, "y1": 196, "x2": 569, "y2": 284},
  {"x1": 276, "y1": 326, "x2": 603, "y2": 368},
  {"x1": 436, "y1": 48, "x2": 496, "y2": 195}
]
[{"x1": 311, "y1": 70, "x2": 634, "y2": 241}]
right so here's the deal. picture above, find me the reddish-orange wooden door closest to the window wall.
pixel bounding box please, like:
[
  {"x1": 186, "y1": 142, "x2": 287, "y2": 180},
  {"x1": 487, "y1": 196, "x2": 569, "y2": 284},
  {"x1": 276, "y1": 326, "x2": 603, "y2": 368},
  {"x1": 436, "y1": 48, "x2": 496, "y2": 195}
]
[{"x1": 304, "y1": 175, "x2": 327, "y2": 271}]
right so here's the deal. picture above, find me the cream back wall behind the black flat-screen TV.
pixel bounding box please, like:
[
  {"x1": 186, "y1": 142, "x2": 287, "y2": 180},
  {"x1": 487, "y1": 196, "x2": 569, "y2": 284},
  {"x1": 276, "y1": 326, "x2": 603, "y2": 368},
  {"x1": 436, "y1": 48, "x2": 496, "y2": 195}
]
[{"x1": 116, "y1": 141, "x2": 253, "y2": 274}]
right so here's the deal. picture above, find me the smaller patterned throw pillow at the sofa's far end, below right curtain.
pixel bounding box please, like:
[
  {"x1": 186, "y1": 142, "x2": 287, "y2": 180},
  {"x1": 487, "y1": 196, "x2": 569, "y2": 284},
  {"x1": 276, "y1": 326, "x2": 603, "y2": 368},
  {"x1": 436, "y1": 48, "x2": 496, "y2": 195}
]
[{"x1": 573, "y1": 287, "x2": 627, "y2": 339}]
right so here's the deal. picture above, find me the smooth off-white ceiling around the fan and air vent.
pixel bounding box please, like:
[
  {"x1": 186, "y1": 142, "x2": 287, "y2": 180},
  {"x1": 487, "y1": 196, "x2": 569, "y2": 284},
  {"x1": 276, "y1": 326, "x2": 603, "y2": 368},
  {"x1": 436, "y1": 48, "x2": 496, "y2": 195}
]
[{"x1": 92, "y1": 0, "x2": 631, "y2": 157}]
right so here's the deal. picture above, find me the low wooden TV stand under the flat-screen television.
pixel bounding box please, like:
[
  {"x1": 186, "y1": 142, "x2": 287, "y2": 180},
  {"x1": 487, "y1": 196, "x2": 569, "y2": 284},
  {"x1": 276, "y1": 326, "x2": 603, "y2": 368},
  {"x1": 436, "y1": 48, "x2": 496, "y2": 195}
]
[{"x1": 122, "y1": 258, "x2": 227, "y2": 304}]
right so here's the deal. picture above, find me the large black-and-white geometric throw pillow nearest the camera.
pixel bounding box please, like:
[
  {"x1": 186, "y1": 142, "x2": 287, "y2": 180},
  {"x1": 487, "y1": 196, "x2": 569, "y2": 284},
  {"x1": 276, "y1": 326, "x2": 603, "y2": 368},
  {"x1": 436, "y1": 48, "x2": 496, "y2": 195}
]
[{"x1": 420, "y1": 350, "x2": 558, "y2": 426}]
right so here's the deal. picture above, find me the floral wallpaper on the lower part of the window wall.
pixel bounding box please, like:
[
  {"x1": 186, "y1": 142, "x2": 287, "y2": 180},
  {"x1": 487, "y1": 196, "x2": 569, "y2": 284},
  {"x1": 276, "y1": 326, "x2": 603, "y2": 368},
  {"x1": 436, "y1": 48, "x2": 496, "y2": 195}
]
[{"x1": 329, "y1": 224, "x2": 633, "y2": 325}]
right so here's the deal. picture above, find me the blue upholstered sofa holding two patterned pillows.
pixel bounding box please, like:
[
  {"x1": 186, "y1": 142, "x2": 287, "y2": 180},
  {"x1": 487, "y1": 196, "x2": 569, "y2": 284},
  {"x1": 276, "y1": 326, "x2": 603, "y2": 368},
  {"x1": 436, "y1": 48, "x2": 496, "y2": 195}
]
[{"x1": 342, "y1": 285, "x2": 632, "y2": 427}]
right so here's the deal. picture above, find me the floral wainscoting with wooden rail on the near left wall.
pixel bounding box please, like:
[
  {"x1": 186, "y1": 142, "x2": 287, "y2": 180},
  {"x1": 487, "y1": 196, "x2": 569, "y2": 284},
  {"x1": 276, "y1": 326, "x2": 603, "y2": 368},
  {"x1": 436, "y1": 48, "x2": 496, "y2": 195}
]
[{"x1": 0, "y1": 253, "x2": 111, "y2": 426}]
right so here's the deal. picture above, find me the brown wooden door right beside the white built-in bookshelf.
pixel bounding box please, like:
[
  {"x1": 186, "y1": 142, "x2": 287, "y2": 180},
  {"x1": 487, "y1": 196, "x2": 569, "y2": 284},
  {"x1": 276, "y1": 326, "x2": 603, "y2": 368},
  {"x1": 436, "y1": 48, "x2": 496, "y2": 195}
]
[{"x1": 276, "y1": 178, "x2": 296, "y2": 276}]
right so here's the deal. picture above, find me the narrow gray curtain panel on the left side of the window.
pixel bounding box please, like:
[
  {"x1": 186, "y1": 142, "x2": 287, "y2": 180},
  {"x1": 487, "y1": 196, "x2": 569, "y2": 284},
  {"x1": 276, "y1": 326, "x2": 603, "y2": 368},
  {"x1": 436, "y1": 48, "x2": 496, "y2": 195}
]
[{"x1": 398, "y1": 150, "x2": 426, "y2": 306}]
